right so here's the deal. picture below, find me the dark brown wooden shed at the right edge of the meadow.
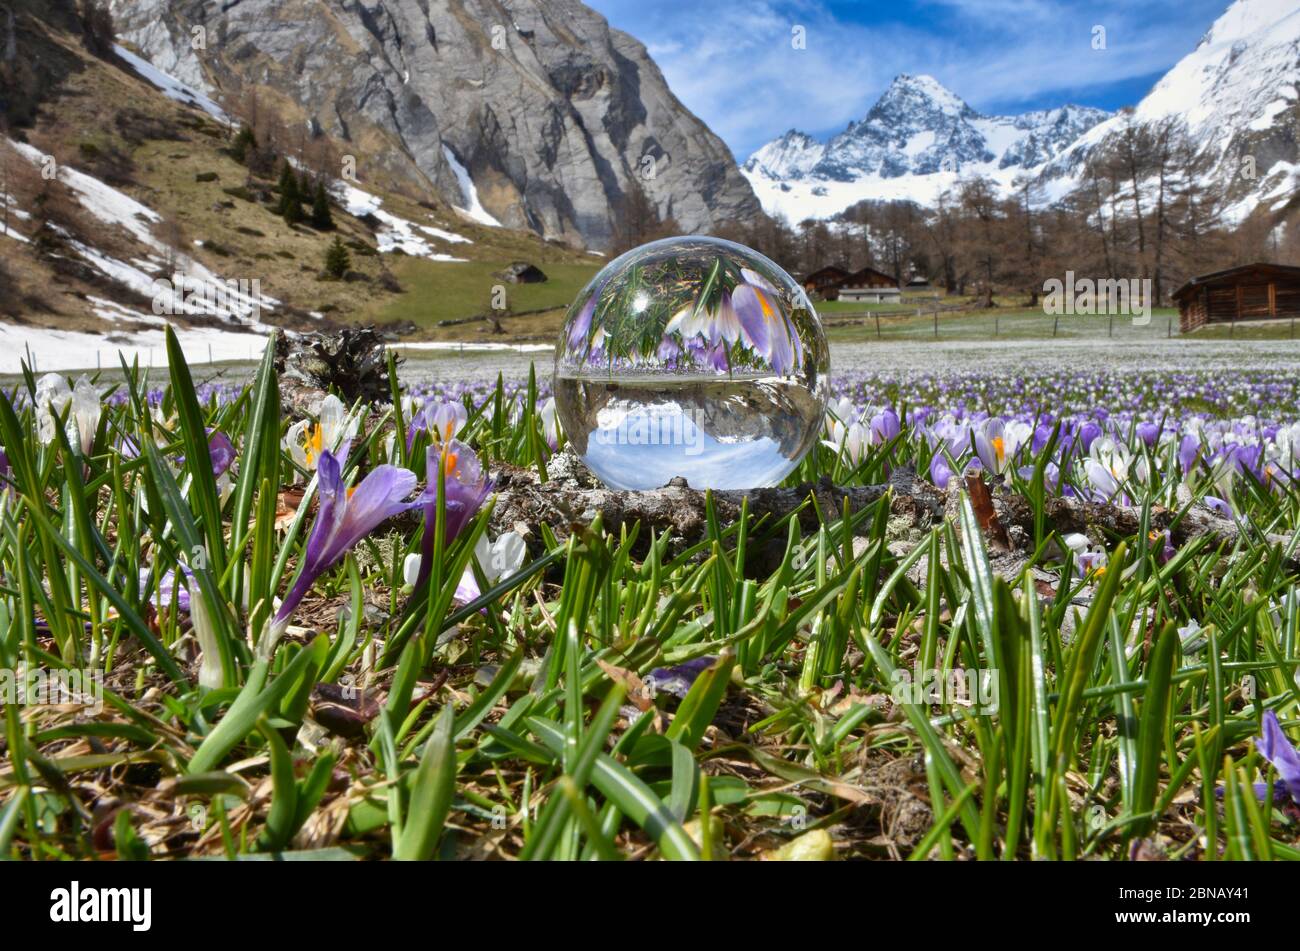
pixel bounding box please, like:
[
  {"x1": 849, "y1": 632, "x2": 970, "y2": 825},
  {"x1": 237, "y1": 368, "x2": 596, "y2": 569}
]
[{"x1": 1173, "y1": 262, "x2": 1300, "y2": 334}]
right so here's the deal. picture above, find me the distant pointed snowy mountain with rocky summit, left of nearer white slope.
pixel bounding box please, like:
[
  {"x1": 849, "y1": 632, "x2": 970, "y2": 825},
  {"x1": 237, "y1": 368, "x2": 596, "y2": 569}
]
[{"x1": 742, "y1": 75, "x2": 1108, "y2": 220}]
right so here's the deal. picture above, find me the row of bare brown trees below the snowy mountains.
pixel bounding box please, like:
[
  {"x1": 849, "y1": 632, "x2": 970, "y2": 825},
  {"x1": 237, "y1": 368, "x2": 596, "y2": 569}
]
[{"x1": 715, "y1": 120, "x2": 1300, "y2": 307}]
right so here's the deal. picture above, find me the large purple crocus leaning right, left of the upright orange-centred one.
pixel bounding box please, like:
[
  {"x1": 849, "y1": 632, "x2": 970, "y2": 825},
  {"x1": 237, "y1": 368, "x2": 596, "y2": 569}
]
[{"x1": 272, "y1": 446, "x2": 416, "y2": 631}]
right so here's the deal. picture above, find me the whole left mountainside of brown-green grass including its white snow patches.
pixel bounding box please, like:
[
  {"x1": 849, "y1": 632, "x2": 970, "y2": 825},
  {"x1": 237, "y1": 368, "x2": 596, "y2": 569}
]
[{"x1": 0, "y1": 0, "x2": 598, "y2": 373}]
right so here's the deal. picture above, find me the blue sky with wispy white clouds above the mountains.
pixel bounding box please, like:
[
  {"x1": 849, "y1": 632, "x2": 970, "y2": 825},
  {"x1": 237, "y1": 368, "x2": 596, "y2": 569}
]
[{"x1": 586, "y1": 0, "x2": 1229, "y2": 161}]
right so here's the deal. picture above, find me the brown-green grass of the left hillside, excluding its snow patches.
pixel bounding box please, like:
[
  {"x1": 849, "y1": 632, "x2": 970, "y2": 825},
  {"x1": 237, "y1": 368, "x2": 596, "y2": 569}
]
[{"x1": 0, "y1": 4, "x2": 599, "y2": 339}]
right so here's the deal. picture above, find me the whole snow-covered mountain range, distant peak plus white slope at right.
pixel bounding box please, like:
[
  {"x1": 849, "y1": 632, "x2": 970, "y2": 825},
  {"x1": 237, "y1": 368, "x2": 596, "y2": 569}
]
[{"x1": 744, "y1": 0, "x2": 1300, "y2": 221}]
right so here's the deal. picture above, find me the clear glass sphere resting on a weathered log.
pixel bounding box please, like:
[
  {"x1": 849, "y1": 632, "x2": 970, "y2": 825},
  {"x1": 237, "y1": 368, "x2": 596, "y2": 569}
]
[{"x1": 555, "y1": 238, "x2": 831, "y2": 488}]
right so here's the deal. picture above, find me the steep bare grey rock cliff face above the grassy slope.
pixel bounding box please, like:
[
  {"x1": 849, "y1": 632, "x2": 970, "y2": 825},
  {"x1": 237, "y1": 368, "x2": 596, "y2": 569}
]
[{"x1": 113, "y1": 0, "x2": 761, "y2": 248}]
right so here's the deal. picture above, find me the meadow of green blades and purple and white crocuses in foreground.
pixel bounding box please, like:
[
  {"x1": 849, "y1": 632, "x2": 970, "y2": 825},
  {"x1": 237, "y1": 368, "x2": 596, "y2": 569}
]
[{"x1": 0, "y1": 340, "x2": 1300, "y2": 861}]
